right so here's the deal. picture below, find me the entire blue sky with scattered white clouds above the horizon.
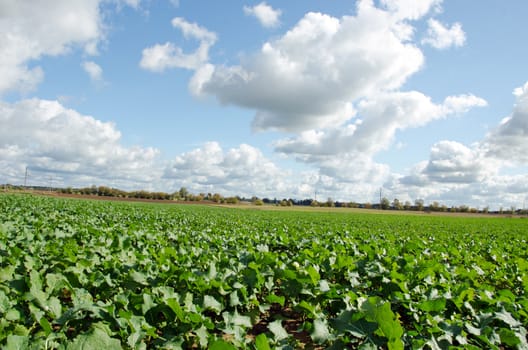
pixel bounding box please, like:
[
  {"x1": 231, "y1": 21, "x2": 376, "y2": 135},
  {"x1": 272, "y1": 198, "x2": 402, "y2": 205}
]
[{"x1": 0, "y1": 0, "x2": 528, "y2": 208}]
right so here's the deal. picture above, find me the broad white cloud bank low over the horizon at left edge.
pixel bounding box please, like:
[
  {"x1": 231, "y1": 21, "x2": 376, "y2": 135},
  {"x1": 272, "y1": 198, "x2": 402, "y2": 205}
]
[{"x1": 0, "y1": 99, "x2": 161, "y2": 188}]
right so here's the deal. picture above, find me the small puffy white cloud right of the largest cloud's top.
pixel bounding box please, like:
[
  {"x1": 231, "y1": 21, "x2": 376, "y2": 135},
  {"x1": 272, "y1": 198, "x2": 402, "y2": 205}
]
[{"x1": 422, "y1": 18, "x2": 466, "y2": 50}]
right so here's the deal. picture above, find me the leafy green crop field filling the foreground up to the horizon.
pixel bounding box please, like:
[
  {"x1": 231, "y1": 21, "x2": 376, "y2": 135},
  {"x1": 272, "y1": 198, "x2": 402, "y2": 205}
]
[{"x1": 0, "y1": 194, "x2": 528, "y2": 349}]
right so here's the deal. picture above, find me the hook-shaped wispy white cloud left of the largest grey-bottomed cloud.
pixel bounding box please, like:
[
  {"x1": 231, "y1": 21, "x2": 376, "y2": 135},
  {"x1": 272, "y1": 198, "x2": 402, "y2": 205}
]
[{"x1": 139, "y1": 17, "x2": 217, "y2": 72}]
